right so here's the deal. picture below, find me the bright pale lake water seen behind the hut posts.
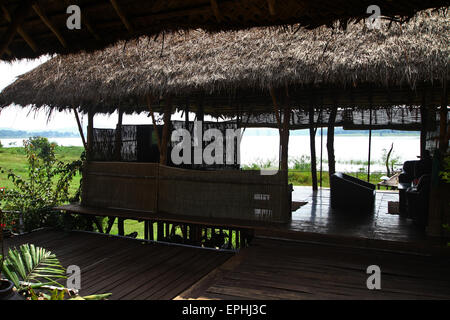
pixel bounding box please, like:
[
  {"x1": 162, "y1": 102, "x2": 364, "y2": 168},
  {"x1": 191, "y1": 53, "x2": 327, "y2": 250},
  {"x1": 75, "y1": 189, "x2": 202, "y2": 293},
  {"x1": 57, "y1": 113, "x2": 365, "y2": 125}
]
[{"x1": 1, "y1": 134, "x2": 420, "y2": 172}]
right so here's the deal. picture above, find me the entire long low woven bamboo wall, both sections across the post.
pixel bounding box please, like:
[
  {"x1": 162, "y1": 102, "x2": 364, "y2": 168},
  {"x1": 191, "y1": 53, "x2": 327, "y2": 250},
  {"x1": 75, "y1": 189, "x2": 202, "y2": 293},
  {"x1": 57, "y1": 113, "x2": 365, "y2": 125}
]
[{"x1": 82, "y1": 162, "x2": 290, "y2": 222}]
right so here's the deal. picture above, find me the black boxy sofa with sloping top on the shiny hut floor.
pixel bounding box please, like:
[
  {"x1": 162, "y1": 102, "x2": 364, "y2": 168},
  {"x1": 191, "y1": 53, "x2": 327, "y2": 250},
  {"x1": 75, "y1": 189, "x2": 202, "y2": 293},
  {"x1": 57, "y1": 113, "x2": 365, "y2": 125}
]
[{"x1": 330, "y1": 173, "x2": 376, "y2": 212}]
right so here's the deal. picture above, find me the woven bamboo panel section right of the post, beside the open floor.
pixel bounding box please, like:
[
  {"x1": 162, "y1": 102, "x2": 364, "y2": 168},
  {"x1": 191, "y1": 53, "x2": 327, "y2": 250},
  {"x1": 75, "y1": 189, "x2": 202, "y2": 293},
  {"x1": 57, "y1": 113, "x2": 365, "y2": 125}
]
[{"x1": 158, "y1": 166, "x2": 290, "y2": 222}]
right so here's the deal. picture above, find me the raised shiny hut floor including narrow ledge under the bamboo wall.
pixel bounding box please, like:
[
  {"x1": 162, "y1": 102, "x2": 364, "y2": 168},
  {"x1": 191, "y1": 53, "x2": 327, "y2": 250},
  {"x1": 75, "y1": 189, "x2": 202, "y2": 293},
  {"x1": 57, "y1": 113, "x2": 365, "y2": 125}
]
[{"x1": 58, "y1": 187, "x2": 447, "y2": 253}]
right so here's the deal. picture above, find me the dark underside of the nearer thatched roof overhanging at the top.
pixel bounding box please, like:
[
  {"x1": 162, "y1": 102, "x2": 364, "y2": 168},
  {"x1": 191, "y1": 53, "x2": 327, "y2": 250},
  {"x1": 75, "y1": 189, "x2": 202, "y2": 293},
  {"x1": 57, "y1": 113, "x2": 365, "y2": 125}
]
[{"x1": 0, "y1": 0, "x2": 448, "y2": 60}]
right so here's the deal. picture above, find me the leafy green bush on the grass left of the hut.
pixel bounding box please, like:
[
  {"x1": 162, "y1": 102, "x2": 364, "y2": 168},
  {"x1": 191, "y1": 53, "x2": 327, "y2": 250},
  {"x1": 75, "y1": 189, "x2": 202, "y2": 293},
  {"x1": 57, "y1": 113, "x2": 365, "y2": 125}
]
[{"x1": 0, "y1": 137, "x2": 82, "y2": 231}]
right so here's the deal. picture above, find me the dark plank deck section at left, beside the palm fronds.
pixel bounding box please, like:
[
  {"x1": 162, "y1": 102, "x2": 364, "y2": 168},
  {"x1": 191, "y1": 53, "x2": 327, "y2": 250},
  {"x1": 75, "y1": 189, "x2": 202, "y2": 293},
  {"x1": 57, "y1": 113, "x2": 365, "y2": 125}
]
[{"x1": 5, "y1": 230, "x2": 232, "y2": 300}]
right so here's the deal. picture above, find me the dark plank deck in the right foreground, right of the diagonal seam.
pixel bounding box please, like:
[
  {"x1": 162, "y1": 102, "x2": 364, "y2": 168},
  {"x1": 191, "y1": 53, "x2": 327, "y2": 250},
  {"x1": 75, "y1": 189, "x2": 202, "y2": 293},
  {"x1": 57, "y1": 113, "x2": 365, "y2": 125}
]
[{"x1": 176, "y1": 238, "x2": 450, "y2": 300}]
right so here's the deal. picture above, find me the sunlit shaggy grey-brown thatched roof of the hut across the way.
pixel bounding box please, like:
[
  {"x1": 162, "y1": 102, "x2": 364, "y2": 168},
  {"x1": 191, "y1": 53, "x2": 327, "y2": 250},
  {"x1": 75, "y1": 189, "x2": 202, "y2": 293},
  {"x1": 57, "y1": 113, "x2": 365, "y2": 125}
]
[{"x1": 0, "y1": 9, "x2": 450, "y2": 114}]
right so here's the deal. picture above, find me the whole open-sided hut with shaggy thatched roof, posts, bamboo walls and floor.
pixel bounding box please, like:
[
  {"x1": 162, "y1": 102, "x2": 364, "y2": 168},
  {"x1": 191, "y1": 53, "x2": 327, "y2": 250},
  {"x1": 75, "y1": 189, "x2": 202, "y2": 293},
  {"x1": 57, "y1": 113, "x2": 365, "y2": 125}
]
[{"x1": 0, "y1": 8, "x2": 449, "y2": 250}]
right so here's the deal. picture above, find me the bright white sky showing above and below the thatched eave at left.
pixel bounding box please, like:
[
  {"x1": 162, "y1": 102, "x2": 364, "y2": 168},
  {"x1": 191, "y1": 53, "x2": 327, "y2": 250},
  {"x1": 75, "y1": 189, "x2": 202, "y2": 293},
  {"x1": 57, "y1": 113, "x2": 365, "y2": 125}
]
[{"x1": 0, "y1": 56, "x2": 189, "y2": 132}]
